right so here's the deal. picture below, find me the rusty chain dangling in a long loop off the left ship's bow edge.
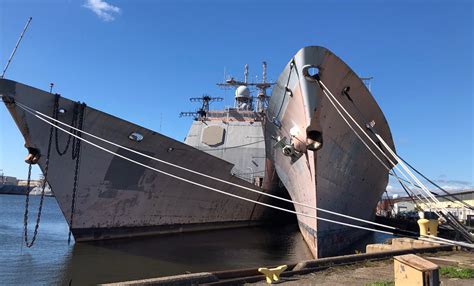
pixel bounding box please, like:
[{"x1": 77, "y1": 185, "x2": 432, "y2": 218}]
[{"x1": 23, "y1": 99, "x2": 57, "y2": 248}]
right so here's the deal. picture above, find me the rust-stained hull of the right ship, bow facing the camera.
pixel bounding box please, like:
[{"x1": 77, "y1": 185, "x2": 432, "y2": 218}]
[{"x1": 266, "y1": 47, "x2": 393, "y2": 258}]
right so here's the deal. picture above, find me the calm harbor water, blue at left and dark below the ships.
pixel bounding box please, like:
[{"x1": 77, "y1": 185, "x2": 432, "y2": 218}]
[{"x1": 0, "y1": 195, "x2": 311, "y2": 285}]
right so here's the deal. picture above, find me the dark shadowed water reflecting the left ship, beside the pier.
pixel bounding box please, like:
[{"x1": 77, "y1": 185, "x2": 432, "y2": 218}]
[{"x1": 62, "y1": 225, "x2": 311, "y2": 285}]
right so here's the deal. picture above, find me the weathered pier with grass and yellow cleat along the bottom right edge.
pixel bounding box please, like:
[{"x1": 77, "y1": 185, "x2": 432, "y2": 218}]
[{"x1": 100, "y1": 239, "x2": 466, "y2": 285}]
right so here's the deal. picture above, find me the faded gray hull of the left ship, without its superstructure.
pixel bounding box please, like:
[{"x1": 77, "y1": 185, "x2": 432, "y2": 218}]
[{"x1": 0, "y1": 79, "x2": 282, "y2": 241}]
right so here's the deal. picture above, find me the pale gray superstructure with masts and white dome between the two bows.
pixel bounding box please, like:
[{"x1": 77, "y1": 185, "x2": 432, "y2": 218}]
[{"x1": 180, "y1": 62, "x2": 276, "y2": 188}]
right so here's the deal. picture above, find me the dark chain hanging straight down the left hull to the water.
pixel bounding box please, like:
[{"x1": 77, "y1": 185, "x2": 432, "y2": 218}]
[{"x1": 67, "y1": 103, "x2": 86, "y2": 244}]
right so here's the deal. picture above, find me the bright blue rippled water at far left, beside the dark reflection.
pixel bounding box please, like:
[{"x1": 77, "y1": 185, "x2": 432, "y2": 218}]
[{"x1": 0, "y1": 195, "x2": 72, "y2": 285}]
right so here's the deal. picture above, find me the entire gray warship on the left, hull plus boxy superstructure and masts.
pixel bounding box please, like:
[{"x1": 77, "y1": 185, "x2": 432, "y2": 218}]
[{"x1": 0, "y1": 63, "x2": 288, "y2": 242}]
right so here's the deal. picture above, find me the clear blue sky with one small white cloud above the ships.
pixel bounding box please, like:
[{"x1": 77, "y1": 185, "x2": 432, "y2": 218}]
[{"x1": 0, "y1": 0, "x2": 474, "y2": 194}]
